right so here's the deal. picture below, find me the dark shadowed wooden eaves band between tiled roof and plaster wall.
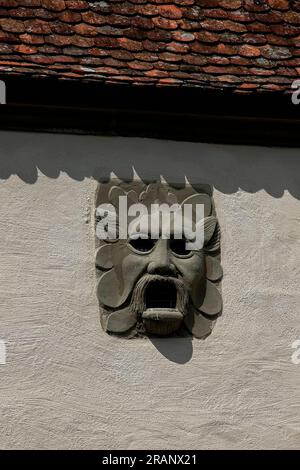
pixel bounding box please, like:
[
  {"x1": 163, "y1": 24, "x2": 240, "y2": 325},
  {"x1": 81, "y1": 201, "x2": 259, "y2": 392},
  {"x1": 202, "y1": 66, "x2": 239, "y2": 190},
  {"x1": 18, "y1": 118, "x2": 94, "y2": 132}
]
[{"x1": 0, "y1": 76, "x2": 300, "y2": 147}]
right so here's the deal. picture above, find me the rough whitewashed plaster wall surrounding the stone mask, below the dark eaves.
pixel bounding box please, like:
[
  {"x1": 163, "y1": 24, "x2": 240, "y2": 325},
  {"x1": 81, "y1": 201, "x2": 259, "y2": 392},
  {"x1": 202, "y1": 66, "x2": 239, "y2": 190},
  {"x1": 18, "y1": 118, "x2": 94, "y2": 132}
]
[{"x1": 0, "y1": 132, "x2": 300, "y2": 449}]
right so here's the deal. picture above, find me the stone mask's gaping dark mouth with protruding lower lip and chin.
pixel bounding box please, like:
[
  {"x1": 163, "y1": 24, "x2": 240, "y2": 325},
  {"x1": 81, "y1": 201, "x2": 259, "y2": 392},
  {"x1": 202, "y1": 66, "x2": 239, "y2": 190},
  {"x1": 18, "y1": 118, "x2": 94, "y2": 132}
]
[{"x1": 142, "y1": 280, "x2": 183, "y2": 336}]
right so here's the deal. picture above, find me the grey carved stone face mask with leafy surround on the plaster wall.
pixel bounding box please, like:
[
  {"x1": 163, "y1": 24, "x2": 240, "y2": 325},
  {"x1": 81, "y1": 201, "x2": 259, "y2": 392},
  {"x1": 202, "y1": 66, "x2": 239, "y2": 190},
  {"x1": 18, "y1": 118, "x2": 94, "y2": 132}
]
[{"x1": 96, "y1": 175, "x2": 222, "y2": 338}]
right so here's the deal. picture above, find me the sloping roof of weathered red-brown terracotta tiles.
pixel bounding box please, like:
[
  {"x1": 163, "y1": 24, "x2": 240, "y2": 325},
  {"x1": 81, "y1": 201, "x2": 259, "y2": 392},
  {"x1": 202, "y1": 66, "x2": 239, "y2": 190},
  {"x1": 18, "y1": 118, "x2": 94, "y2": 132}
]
[{"x1": 0, "y1": 0, "x2": 300, "y2": 93}]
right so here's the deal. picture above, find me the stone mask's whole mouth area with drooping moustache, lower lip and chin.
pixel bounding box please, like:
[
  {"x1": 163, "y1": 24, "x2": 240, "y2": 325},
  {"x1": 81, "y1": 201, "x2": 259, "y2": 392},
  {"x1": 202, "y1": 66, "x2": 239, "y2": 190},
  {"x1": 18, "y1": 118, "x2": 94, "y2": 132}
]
[{"x1": 130, "y1": 274, "x2": 190, "y2": 335}]
